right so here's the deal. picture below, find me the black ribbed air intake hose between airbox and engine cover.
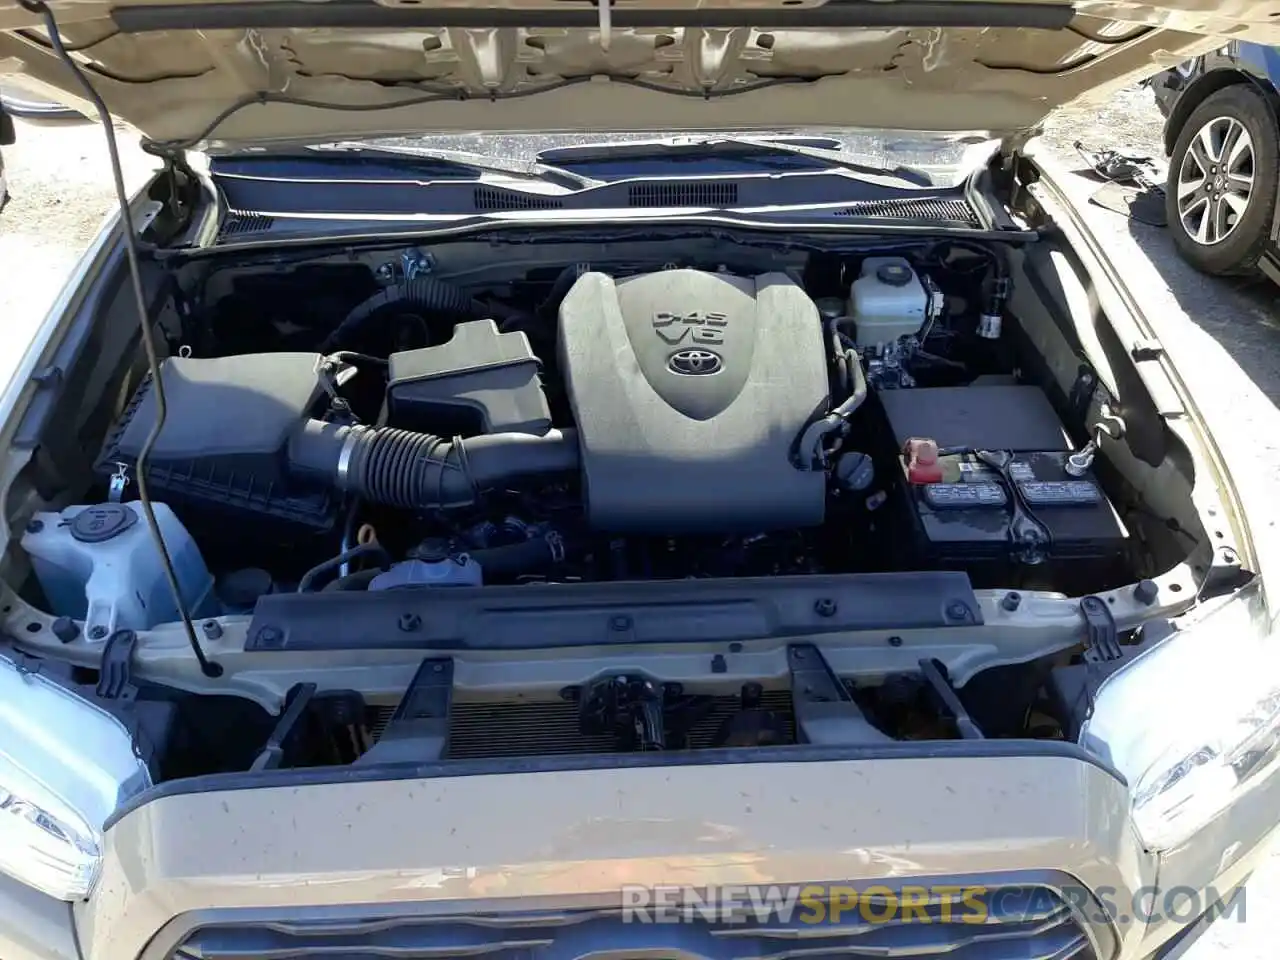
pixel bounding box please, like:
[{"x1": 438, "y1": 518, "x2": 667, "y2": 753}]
[{"x1": 289, "y1": 420, "x2": 579, "y2": 509}]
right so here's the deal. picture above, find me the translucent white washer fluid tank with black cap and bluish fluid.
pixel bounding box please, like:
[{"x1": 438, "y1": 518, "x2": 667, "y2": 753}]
[{"x1": 22, "y1": 503, "x2": 218, "y2": 640}]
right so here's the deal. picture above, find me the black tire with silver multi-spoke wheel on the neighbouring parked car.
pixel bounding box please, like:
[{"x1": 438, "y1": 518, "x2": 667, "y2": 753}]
[{"x1": 1165, "y1": 84, "x2": 1280, "y2": 275}]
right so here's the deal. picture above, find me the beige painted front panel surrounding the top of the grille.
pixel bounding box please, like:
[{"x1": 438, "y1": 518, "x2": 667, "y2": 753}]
[{"x1": 0, "y1": 751, "x2": 1269, "y2": 960}]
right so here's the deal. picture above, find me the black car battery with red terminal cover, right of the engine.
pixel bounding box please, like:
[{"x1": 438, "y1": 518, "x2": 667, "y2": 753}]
[{"x1": 881, "y1": 385, "x2": 1129, "y2": 576}]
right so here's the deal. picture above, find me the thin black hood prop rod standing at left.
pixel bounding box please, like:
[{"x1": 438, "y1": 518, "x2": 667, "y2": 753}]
[{"x1": 19, "y1": 0, "x2": 223, "y2": 677}]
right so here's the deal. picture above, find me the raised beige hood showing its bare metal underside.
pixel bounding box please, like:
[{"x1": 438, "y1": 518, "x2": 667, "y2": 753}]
[{"x1": 0, "y1": 0, "x2": 1280, "y2": 148}]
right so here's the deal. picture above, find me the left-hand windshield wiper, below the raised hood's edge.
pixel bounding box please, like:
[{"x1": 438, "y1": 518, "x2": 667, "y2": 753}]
[{"x1": 218, "y1": 142, "x2": 600, "y2": 189}]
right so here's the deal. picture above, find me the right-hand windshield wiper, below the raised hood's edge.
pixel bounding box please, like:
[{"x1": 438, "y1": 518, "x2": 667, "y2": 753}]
[{"x1": 536, "y1": 136, "x2": 933, "y2": 187}]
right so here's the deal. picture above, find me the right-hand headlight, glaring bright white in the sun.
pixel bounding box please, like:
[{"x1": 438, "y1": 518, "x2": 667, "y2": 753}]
[{"x1": 1080, "y1": 581, "x2": 1280, "y2": 850}]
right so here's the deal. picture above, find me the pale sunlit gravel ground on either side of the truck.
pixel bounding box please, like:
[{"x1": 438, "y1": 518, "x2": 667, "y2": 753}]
[{"x1": 0, "y1": 88, "x2": 1280, "y2": 960}]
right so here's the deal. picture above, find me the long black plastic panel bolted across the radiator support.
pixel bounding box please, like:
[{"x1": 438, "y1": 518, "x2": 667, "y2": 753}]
[{"x1": 244, "y1": 571, "x2": 982, "y2": 652}]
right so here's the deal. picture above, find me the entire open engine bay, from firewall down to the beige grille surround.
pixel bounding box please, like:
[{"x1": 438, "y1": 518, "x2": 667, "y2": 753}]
[{"x1": 6, "y1": 221, "x2": 1228, "y2": 782}]
